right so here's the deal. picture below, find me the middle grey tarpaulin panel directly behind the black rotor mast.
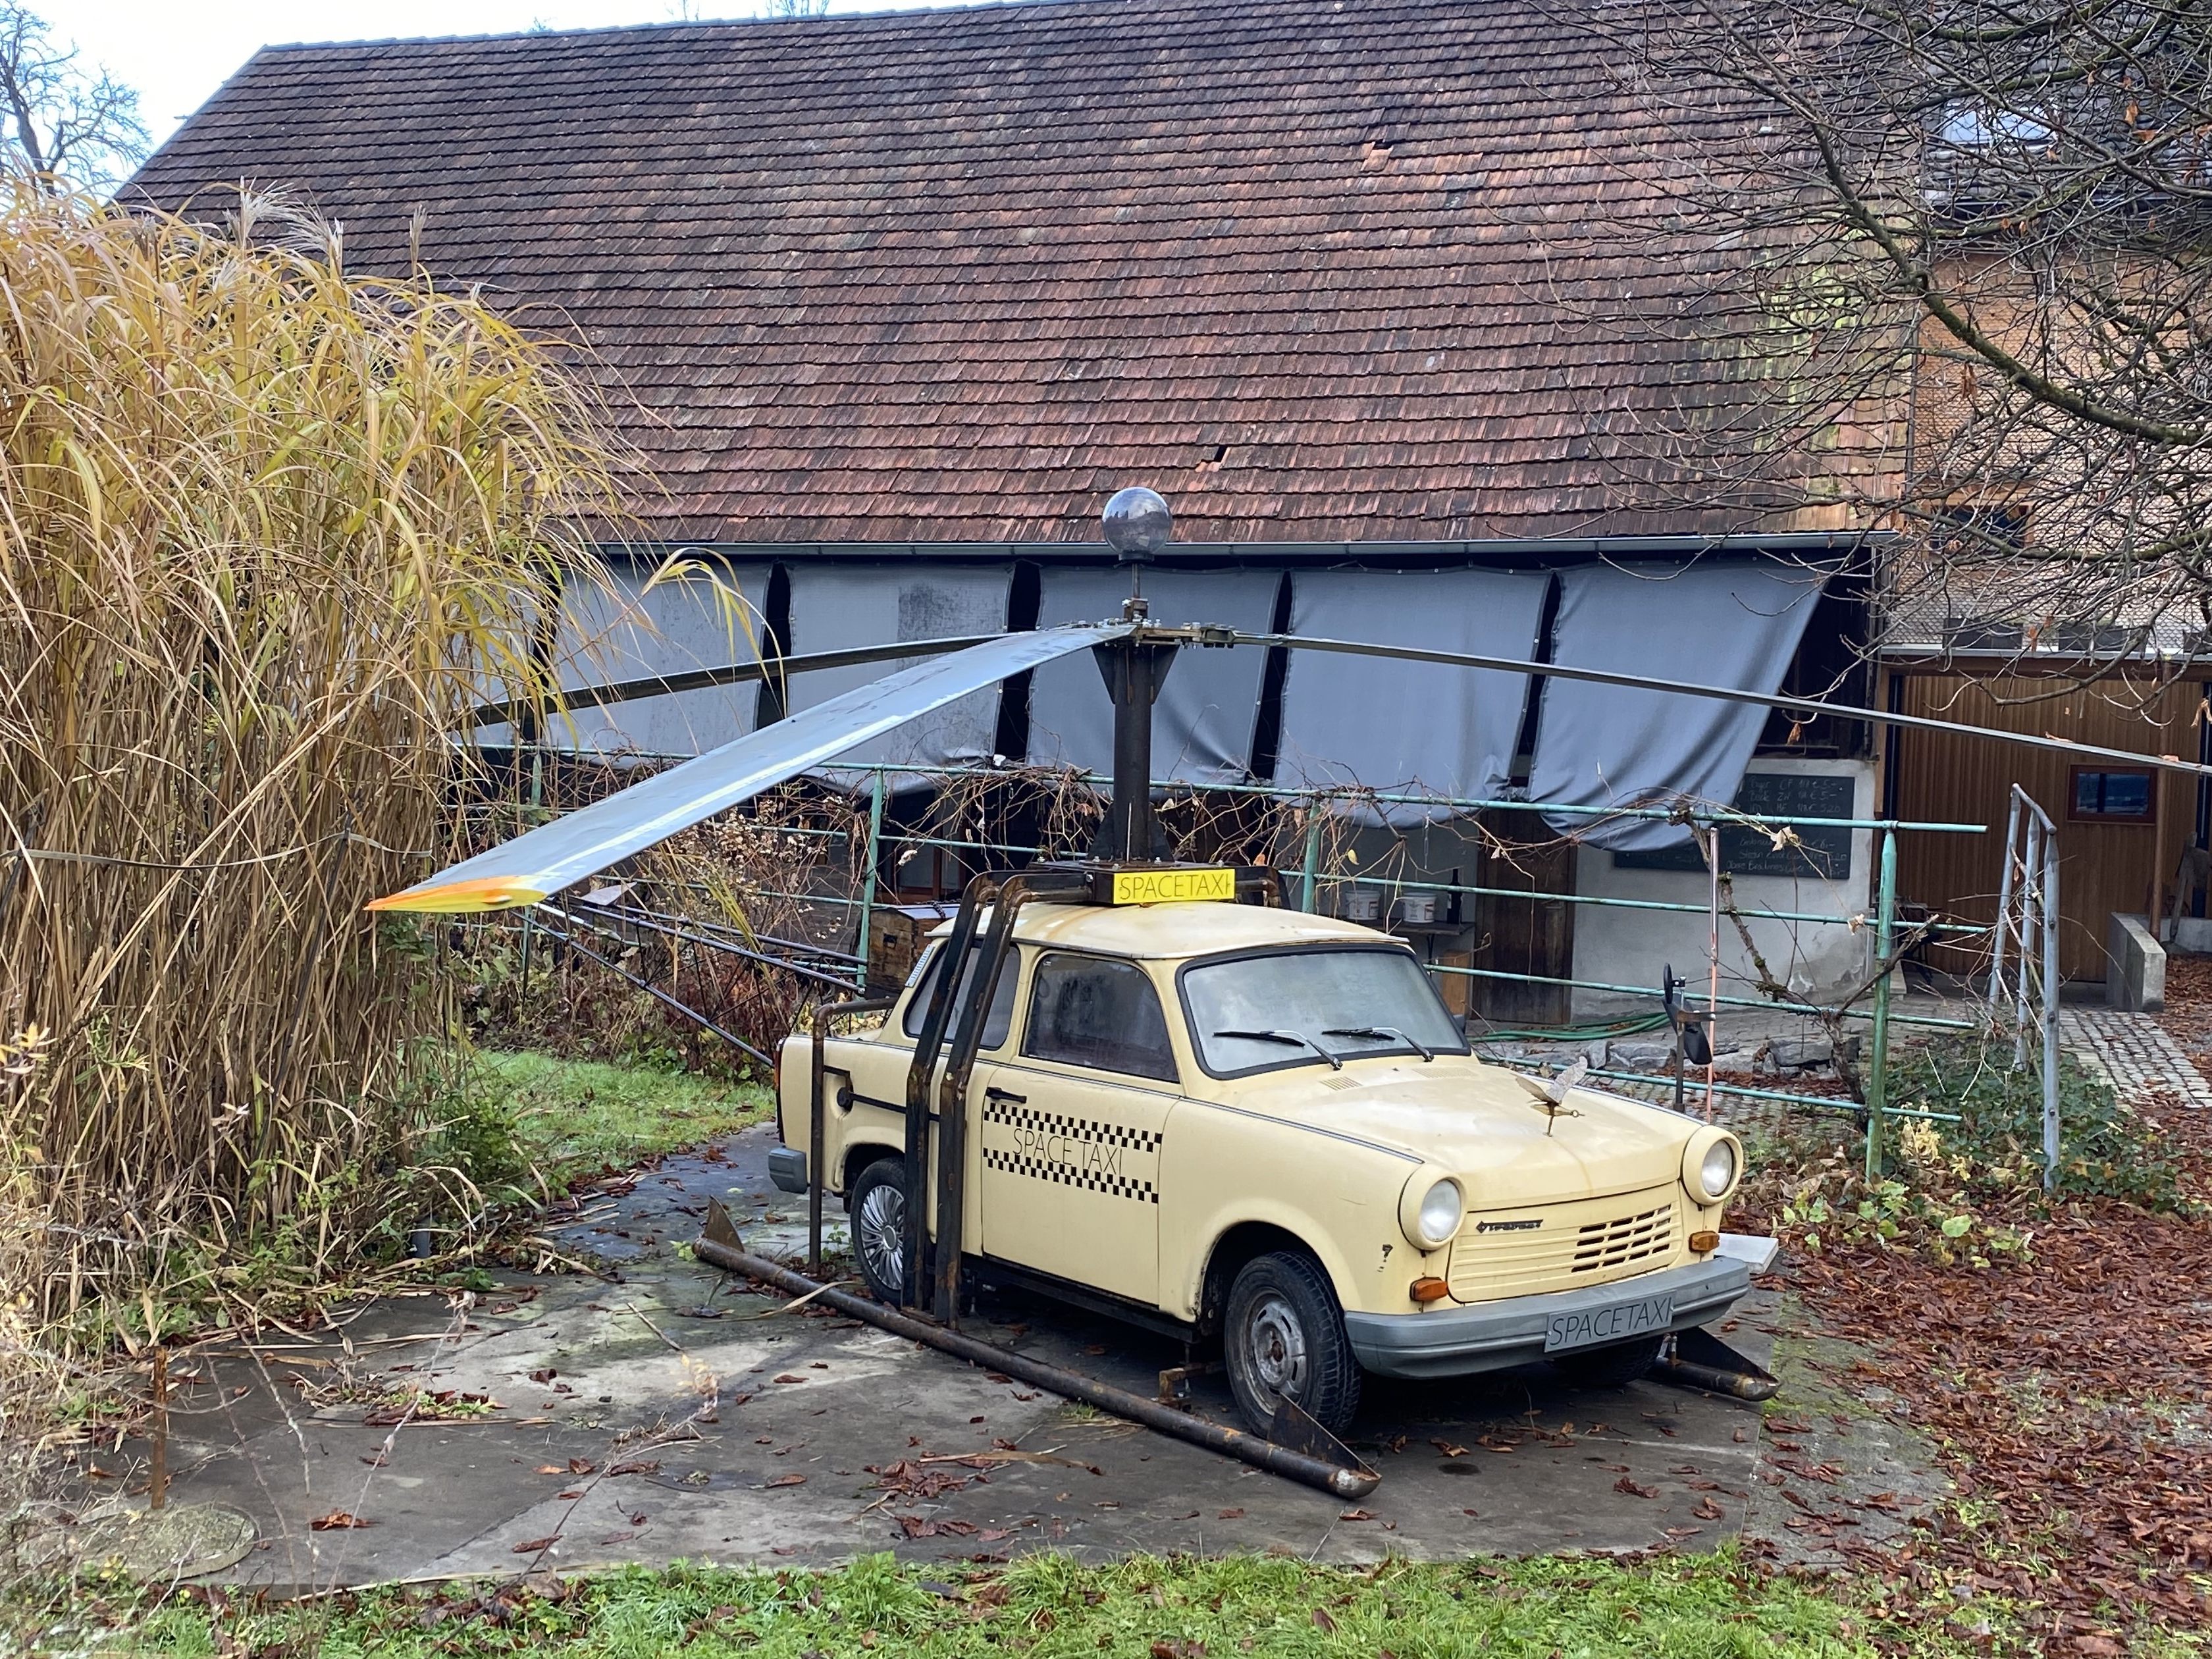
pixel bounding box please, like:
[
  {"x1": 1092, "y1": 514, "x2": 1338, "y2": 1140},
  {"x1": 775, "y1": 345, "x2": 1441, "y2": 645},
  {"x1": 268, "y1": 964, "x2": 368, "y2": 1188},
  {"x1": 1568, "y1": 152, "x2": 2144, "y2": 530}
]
[{"x1": 1028, "y1": 569, "x2": 1280, "y2": 783}]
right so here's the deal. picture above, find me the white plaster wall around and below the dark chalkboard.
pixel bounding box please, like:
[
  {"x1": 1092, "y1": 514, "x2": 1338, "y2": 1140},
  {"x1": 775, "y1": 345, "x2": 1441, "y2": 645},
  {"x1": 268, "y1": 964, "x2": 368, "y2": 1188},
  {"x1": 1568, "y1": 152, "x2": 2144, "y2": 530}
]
[{"x1": 1575, "y1": 758, "x2": 1874, "y2": 1020}]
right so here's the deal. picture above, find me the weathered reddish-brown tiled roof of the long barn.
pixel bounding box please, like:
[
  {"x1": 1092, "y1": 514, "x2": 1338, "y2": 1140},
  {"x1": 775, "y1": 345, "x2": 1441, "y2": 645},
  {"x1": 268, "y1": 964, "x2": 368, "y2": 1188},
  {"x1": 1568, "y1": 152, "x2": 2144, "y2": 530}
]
[{"x1": 137, "y1": 0, "x2": 1814, "y2": 542}]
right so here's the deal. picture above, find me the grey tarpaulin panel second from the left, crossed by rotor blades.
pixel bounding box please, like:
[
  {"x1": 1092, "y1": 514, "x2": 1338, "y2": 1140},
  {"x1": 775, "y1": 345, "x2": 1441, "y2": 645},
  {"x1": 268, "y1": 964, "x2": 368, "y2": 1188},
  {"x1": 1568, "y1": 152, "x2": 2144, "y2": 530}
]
[{"x1": 785, "y1": 564, "x2": 1013, "y2": 783}]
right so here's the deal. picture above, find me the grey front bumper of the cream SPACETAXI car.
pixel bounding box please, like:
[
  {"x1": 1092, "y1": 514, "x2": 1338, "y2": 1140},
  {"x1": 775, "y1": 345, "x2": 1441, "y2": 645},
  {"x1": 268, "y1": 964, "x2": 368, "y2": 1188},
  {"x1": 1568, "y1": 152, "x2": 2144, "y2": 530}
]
[{"x1": 1345, "y1": 1256, "x2": 1752, "y2": 1376}]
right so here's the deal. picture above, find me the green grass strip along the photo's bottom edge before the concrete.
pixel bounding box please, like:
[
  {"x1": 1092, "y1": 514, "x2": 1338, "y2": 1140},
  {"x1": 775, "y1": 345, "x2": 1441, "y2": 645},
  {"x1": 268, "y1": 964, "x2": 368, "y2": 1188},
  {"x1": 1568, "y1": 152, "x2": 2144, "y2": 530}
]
[{"x1": 65, "y1": 1553, "x2": 1989, "y2": 1659}]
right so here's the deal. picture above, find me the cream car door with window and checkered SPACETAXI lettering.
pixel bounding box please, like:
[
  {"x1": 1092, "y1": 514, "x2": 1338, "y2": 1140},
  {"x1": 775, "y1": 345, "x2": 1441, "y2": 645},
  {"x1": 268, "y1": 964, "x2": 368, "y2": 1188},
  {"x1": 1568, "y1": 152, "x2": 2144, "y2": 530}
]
[{"x1": 973, "y1": 951, "x2": 1181, "y2": 1305}]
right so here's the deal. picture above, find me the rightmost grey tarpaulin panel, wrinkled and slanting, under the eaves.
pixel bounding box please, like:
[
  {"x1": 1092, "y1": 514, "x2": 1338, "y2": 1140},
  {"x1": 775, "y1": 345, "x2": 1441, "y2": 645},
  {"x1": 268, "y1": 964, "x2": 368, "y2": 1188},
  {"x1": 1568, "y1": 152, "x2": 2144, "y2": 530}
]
[{"x1": 1529, "y1": 564, "x2": 1825, "y2": 852}]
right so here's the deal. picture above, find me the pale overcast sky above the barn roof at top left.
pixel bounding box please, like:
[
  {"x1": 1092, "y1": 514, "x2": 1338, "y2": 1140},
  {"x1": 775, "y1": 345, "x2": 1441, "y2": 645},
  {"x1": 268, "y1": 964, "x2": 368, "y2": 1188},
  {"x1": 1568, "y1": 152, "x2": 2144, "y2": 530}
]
[{"x1": 51, "y1": 0, "x2": 958, "y2": 144}]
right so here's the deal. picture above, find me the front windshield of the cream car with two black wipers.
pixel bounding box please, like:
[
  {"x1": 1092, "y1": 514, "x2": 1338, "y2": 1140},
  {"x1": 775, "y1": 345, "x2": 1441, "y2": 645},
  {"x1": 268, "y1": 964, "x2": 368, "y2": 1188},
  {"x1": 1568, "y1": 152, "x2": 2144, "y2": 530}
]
[{"x1": 1181, "y1": 947, "x2": 1467, "y2": 1077}]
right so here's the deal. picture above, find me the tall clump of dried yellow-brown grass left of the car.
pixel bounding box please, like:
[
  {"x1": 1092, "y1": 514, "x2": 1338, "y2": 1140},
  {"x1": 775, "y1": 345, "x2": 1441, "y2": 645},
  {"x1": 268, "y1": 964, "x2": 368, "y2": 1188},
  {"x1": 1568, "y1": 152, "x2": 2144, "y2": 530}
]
[{"x1": 0, "y1": 184, "x2": 617, "y2": 1340}]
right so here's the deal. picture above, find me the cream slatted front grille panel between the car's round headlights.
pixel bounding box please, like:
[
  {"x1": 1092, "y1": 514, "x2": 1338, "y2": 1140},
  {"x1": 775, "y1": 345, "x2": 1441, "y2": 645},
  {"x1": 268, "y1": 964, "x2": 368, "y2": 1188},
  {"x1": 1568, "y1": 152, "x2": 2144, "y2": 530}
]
[{"x1": 1444, "y1": 1186, "x2": 1681, "y2": 1303}]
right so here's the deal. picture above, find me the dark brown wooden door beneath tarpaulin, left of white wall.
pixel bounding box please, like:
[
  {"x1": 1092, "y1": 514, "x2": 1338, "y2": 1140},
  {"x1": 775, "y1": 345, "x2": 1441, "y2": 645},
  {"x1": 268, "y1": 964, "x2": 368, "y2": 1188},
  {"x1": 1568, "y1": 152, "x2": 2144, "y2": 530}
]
[{"x1": 1473, "y1": 812, "x2": 1575, "y2": 1028}]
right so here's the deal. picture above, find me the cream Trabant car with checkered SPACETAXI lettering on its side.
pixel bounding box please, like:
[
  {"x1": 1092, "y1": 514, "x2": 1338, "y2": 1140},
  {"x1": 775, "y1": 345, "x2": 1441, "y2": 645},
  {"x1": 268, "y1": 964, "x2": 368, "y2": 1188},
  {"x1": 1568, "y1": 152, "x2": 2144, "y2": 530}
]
[{"x1": 770, "y1": 903, "x2": 1750, "y2": 1431}]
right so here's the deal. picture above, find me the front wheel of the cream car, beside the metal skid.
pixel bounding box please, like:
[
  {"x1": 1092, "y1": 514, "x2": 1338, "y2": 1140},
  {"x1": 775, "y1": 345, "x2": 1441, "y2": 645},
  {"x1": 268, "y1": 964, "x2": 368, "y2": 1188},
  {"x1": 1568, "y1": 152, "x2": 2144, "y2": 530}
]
[{"x1": 1221, "y1": 1250, "x2": 1360, "y2": 1433}]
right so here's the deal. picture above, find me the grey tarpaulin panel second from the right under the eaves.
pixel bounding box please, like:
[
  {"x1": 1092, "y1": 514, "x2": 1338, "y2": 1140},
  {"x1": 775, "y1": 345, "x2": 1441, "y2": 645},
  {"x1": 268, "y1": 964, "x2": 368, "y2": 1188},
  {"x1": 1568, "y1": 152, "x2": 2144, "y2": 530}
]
[{"x1": 1274, "y1": 571, "x2": 1550, "y2": 825}]
